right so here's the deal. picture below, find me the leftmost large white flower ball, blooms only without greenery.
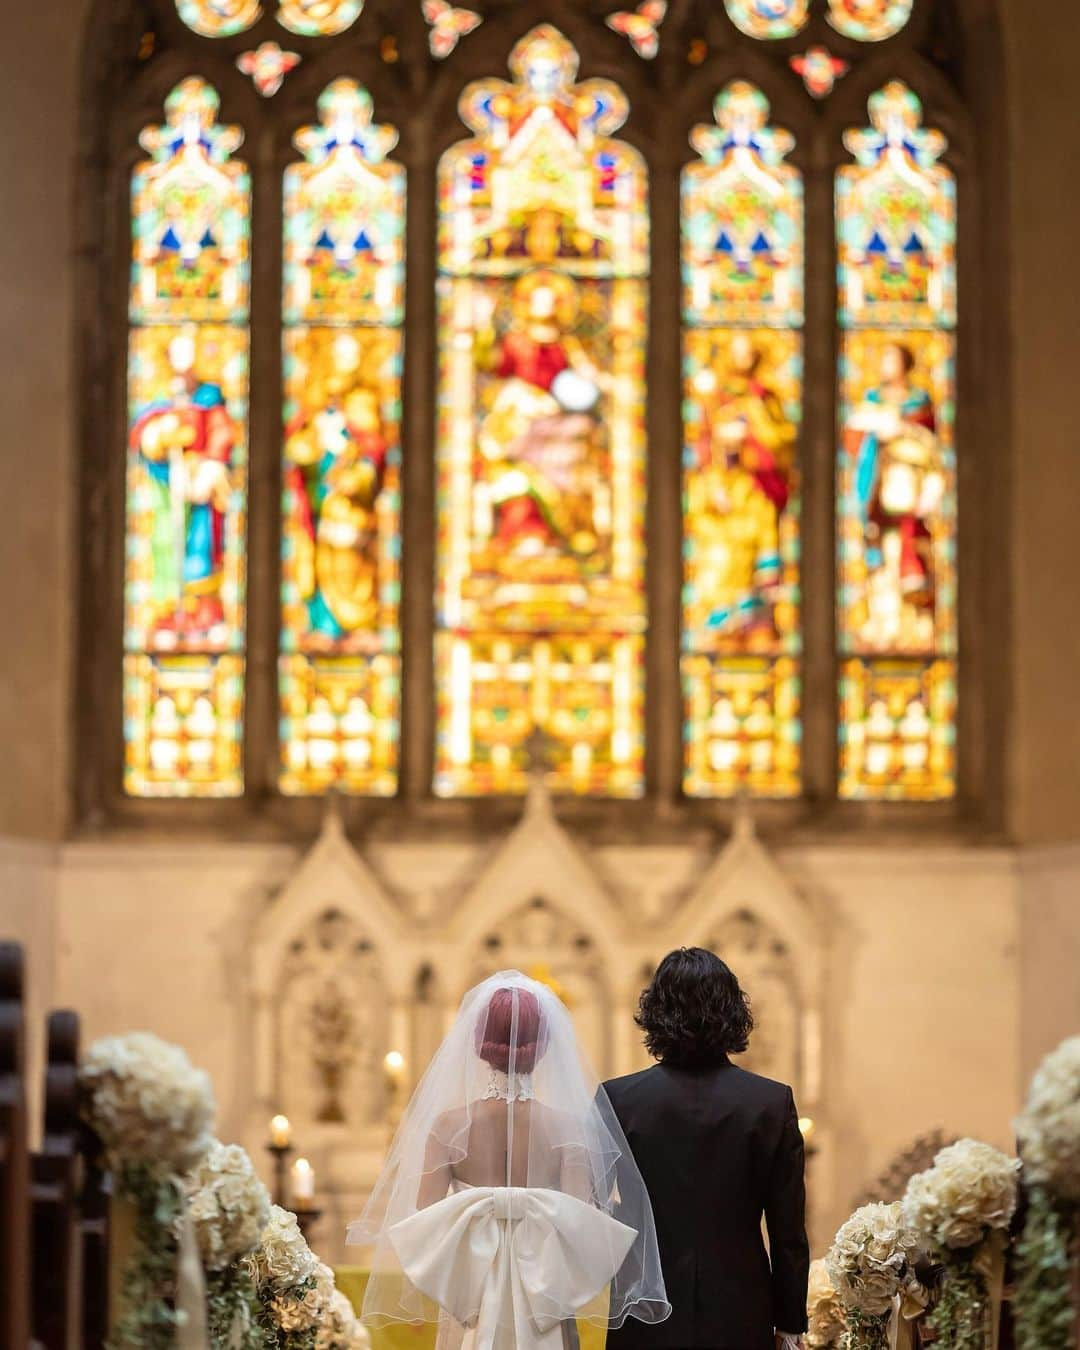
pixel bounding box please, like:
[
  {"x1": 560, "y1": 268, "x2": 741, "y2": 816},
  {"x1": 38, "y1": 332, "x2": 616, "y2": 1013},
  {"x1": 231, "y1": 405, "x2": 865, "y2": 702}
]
[{"x1": 80, "y1": 1031, "x2": 215, "y2": 1176}]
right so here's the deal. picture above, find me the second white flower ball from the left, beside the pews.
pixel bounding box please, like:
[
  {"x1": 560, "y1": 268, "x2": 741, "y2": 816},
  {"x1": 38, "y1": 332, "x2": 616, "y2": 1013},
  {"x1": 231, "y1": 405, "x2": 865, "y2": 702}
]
[{"x1": 184, "y1": 1139, "x2": 270, "y2": 1270}]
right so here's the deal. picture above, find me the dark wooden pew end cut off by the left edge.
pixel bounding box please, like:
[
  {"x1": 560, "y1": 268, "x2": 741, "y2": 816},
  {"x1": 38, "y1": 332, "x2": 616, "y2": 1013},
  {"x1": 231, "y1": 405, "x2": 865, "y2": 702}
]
[{"x1": 0, "y1": 942, "x2": 30, "y2": 1350}]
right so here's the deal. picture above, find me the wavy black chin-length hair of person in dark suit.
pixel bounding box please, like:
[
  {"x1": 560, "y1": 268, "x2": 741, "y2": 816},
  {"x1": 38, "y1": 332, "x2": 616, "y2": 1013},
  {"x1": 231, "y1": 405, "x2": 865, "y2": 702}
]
[{"x1": 635, "y1": 946, "x2": 753, "y2": 1069}]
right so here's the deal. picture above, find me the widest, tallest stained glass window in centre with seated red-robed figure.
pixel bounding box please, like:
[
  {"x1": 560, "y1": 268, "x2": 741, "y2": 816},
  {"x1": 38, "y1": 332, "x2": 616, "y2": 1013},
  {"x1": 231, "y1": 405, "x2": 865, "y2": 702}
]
[{"x1": 435, "y1": 24, "x2": 648, "y2": 797}]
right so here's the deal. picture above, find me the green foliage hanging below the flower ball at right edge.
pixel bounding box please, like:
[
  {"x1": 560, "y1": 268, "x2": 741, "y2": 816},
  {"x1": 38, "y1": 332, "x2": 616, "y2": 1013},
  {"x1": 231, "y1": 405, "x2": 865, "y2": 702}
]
[{"x1": 1013, "y1": 1189, "x2": 1077, "y2": 1350}]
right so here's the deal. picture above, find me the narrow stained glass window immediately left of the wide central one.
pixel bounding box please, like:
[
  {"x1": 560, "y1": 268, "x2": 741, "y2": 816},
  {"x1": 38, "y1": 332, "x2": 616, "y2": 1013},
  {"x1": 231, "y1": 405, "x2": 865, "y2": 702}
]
[{"x1": 279, "y1": 80, "x2": 405, "y2": 795}]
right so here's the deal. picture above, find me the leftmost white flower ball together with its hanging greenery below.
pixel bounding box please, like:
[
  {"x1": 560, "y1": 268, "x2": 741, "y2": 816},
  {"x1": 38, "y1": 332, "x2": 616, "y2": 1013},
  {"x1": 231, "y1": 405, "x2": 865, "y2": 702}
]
[{"x1": 80, "y1": 1031, "x2": 215, "y2": 1350}]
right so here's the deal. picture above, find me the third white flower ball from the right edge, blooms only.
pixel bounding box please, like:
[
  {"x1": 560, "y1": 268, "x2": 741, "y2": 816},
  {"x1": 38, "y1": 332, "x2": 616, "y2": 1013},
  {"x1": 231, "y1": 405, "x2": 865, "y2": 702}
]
[{"x1": 825, "y1": 1203, "x2": 919, "y2": 1319}]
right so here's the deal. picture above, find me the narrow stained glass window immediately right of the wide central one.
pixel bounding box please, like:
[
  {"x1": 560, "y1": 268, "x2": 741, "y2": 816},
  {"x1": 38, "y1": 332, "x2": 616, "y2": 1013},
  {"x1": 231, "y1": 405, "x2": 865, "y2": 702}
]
[{"x1": 682, "y1": 81, "x2": 803, "y2": 797}]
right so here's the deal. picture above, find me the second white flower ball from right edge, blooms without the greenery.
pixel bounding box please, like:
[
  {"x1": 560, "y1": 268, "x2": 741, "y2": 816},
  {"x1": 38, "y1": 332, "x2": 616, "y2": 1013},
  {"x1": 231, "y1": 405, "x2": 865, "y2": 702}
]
[{"x1": 903, "y1": 1139, "x2": 1021, "y2": 1250}]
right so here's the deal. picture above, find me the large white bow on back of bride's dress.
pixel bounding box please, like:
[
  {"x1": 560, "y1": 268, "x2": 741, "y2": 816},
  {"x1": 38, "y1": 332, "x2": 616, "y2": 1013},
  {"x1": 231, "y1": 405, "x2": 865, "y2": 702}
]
[{"x1": 389, "y1": 1187, "x2": 637, "y2": 1350}]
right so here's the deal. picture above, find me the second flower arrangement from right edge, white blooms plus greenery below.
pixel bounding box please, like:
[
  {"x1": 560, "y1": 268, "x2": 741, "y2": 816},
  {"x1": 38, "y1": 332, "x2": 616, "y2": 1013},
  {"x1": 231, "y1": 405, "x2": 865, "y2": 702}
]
[{"x1": 903, "y1": 1139, "x2": 1019, "y2": 1350}]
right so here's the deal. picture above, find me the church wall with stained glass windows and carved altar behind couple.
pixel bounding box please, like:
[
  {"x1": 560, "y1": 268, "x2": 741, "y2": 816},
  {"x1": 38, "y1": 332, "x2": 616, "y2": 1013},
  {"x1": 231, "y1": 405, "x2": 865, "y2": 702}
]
[{"x1": 0, "y1": 0, "x2": 1080, "y2": 1339}]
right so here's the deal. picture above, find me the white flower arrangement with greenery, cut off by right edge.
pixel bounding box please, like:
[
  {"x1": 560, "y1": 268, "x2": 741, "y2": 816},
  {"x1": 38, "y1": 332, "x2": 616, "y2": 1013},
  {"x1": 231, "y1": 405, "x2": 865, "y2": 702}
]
[{"x1": 1014, "y1": 1037, "x2": 1080, "y2": 1350}]
